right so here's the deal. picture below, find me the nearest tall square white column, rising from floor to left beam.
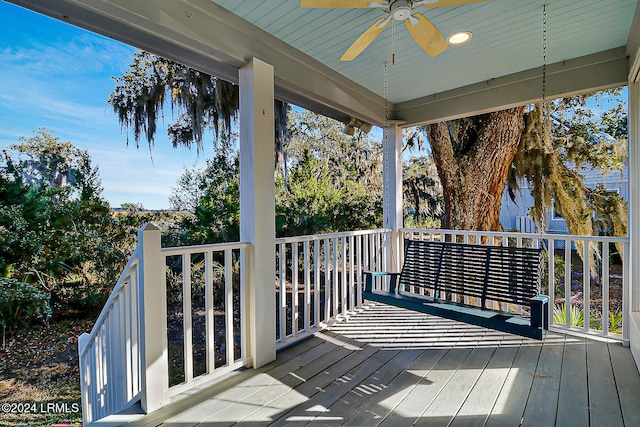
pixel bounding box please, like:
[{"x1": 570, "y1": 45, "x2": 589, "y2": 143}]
[{"x1": 239, "y1": 58, "x2": 276, "y2": 368}]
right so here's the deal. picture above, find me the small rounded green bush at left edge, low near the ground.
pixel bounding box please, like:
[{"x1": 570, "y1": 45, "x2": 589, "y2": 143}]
[{"x1": 0, "y1": 277, "x2": 51, "y2": 331}]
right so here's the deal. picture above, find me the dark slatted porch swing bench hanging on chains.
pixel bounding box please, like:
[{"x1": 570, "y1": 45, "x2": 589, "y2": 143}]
[{"x1": 363, "y1": 6, "x2": 549, "y2": 340}]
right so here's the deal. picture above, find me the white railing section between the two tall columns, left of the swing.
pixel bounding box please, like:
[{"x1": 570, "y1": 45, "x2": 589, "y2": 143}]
[{"x1": 276, "y1": 229, "x2": 391, "y2": 348}]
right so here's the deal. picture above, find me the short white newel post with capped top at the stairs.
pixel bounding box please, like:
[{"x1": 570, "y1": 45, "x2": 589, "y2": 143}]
[{"x1": 138, "y1": 223, "x2": 169, "y2": 413}]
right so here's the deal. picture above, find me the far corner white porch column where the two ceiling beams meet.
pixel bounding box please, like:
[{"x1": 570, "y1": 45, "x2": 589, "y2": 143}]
[{"x1": 382, "y1": 122, "x2": 404, "y2": 271}]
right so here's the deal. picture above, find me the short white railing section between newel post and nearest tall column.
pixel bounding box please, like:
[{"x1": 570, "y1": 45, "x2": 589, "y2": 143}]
[{"x1": 162, "y1": 243, "x2": 249, "y2": 398}]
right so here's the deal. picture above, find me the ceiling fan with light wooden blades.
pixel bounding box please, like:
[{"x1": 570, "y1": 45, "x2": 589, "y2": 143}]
[{"x1": 300, "y1": 0, "x2": 488, "y2": 61}]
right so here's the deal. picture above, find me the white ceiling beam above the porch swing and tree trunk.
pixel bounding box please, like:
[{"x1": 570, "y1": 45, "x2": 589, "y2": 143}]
[{"x1": 394, "y1": 46, "x2": 629, "y2": 127}]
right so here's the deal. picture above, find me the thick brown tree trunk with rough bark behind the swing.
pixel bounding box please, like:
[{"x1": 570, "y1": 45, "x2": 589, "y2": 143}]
[{"x1": 427, "y1": 107, "x2": 524, "y2": 231}]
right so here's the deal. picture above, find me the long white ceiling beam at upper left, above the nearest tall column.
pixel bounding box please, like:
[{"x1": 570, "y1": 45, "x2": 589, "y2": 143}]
[{"x1": 9, "y1": 0, "x2": 385, "y2": 125}]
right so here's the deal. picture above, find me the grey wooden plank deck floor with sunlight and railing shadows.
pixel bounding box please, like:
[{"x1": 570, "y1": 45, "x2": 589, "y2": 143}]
[{"x1": 126, "y1": 305, "x2": 640, "y2": 427}]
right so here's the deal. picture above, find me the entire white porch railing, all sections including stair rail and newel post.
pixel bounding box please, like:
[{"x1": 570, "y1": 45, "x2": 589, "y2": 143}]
[{"x1": 78, "y1": 225, "x2": 630, "y2": 424}]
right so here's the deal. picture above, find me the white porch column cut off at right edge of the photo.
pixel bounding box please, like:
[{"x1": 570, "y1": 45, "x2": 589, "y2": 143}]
[{"x1": 628, "y1": 81, "x2": 640, "y2": 367}]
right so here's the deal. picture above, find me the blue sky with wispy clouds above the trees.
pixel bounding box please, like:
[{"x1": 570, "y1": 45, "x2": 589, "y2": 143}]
[{"x1": 0, "y1": 2, "x2": 211, "y2": 209}]
